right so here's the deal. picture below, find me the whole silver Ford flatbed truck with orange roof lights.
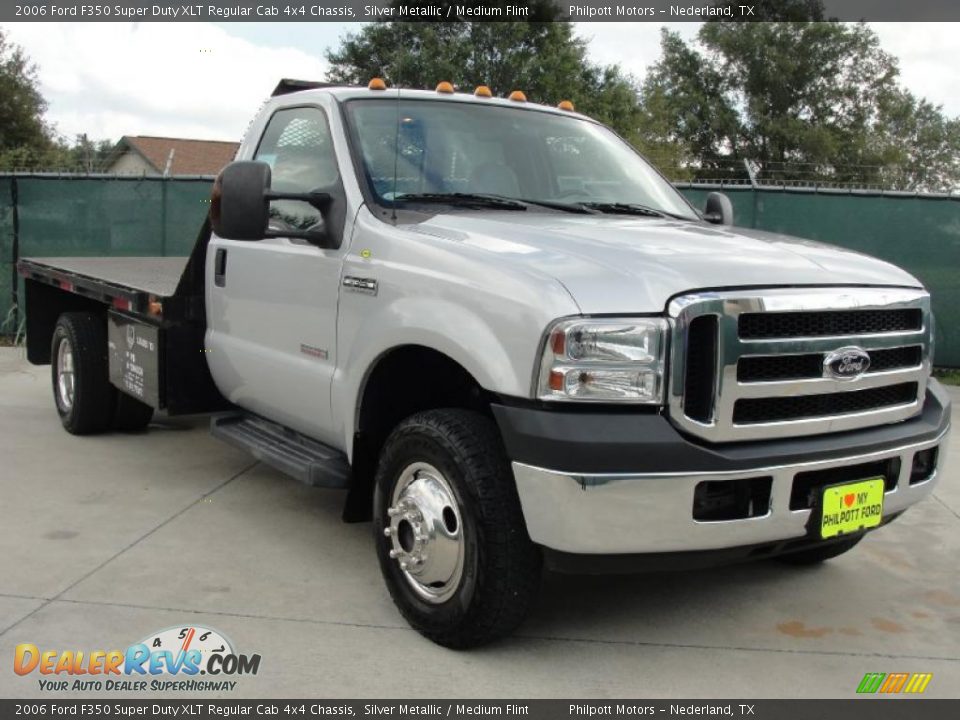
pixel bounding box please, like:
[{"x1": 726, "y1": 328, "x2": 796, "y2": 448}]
[{"x1": 19, "y1": 81, "x2": 950, "y2": 647}]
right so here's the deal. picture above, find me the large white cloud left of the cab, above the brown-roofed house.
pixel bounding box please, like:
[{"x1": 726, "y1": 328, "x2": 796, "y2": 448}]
[{"x1": 5, "y1": 23, "x2": 326, "y2": 140}]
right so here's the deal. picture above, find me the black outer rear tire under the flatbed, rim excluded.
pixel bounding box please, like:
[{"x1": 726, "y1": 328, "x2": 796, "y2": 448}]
[{"x1": 50, "y1": 312, "x2": 117, "y2": 435}]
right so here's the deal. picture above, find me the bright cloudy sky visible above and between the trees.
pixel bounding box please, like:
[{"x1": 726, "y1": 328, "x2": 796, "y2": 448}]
[{"x1": 3, "y1": 22, "x2": 960, "y2": 140}]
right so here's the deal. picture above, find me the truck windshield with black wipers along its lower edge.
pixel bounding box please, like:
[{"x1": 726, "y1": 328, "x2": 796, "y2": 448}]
[{"x1": 346, "y1": 99, "x2": 698, "y2": 220}]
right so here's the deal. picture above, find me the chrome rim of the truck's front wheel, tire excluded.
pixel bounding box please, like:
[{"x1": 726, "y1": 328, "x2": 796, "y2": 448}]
[{"x1": 383, "y1": 462, "x2": 464, "y2": 604}]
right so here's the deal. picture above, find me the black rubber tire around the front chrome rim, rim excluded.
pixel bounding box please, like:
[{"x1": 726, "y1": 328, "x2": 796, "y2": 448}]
[{"x1": 373, "y1": 410, "x2": 542, "y2": 648}]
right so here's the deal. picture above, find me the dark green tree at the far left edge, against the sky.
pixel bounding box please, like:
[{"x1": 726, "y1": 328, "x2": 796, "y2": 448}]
[{"x1": 0, "y1": 28, "x2": 50, "y2": 151}]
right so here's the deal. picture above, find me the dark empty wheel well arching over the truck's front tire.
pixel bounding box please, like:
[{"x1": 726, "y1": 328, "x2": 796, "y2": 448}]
[{"x1": 344, "y1": 345, "x2": 490, "y2": 522}]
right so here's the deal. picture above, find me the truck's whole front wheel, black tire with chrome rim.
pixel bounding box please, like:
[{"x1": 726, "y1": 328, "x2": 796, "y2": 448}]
[{"x1": 374, "y1": 410, "x2": 542, "y2": 648}]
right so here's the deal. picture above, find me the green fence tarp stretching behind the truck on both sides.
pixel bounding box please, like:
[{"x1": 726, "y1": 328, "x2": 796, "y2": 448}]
[{"x1": 0, "y1": 176, "x2": 960, "y2": 367}]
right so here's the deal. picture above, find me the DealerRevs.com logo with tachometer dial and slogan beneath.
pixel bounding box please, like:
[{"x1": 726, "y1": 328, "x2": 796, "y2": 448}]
[{"x1": 13, "y1": 625, "x2": 260, "y2": 692}]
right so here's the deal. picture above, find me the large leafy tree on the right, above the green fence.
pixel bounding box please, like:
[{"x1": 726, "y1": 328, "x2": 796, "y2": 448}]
[{"x1": 639, "y1": 0, "x2": 960, "y2": 189}]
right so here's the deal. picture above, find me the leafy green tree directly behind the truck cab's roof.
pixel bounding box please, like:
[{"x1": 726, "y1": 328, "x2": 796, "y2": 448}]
[{"x1": 327, "y1": 0, "x2": 638, "y2": 134}]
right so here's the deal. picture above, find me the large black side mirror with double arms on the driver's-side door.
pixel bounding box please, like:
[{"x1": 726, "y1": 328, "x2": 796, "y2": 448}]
[{"x1": 210, "y1": 160, "x2": 333, "y2": 245}]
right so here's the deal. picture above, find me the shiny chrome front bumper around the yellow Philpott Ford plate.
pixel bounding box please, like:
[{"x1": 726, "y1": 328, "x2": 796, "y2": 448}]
[{"x1": 513, "y1": 427, "x2": 949, "y2": 554}]
